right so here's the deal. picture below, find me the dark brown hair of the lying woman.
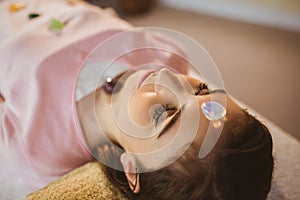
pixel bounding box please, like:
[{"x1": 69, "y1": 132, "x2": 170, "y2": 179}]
[{"x1": 99, "y1": 111, "x2": 273, "y2": 200}]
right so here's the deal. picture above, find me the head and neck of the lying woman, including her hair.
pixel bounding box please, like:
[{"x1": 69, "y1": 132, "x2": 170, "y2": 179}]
[{"x1": 78, "y1": 68, "x2": 273, "y2": 199}]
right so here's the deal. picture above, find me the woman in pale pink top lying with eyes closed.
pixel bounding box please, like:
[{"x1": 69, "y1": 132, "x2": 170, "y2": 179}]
[{"x1": 0, "y1": 0, "x2": 273, "y2": 199}]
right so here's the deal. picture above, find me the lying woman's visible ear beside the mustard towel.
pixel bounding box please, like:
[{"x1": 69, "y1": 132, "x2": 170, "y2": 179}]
[{"x1": 120, "y1": 152, "x2": 140, "y2": 193}]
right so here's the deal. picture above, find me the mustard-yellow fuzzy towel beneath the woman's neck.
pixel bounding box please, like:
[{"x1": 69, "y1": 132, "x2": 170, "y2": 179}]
[{"x1": 26, "y1": 161, "x2": 126, "y2": 200}]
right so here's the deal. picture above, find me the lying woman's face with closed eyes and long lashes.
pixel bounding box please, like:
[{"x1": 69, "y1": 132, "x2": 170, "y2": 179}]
[{"x1": 98, "y1": 68, "x2": 241, "y2": 170}]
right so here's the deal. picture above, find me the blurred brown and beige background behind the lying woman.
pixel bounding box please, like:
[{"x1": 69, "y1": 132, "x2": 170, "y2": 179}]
[{"x1": 91, "y1": 0, "x2": 300, "y2": 139}]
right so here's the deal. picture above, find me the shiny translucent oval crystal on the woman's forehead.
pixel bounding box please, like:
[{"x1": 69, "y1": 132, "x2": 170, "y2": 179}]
[{"x1": 201, "y1": 101, "x2": 226, "y2": 120}]
